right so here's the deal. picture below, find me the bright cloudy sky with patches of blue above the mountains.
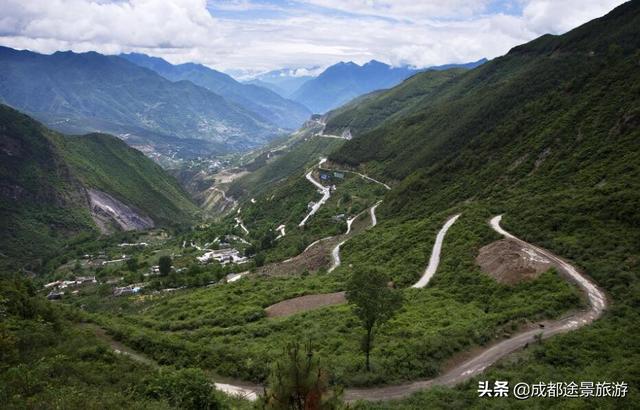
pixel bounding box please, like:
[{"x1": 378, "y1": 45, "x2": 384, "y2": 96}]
[{"x1": 0, "y1": 0, "x2": 624, "y2": 74}]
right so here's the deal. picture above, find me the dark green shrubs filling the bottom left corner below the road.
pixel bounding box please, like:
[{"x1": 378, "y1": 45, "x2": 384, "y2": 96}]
[{"x1": 0, "y1": 279, "x2": 229, "y2": 409}]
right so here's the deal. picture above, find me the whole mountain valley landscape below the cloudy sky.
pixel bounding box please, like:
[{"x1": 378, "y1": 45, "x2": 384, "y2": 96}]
[{"x1": 0, "y1": 0, "x2": 640, "y2": 410}]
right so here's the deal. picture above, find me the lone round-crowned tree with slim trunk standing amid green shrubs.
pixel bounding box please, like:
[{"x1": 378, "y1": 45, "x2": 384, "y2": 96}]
[{"x1": 346, "y1": 270, "x2": 402, "y2": 371}]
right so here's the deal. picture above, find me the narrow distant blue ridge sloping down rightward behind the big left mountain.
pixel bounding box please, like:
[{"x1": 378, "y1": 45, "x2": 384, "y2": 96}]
[{"x1": 120, "y1": 53, "x2": 311, "y2": 129}]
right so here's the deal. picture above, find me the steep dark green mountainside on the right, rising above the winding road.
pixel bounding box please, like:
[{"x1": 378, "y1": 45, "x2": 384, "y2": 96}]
[{"x1": 320, "y1": 1, "x2": 640, "y2": 409}]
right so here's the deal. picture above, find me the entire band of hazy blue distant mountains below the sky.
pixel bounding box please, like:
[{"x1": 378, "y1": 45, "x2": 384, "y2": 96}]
[{"x1": 0, "y1": 47, "x2": 478, "y2": 158}]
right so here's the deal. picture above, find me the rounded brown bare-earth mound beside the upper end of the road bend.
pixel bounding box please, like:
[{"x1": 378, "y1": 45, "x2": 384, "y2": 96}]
[{"x1": 476, "y1": 239, "x2": 553, "y2": 285}]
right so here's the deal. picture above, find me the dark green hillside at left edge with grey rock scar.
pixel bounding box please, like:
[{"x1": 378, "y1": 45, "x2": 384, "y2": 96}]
[{"x1": 0, "y1": 105, "x2": 198, "y2": 269}]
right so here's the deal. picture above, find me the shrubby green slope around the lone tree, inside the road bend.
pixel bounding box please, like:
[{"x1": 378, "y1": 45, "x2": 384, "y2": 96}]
[{"x1": 67, "y1": 208, "x2": 581, "y2": 386}]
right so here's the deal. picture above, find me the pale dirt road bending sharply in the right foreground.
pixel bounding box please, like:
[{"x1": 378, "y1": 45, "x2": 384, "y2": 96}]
[{"x1": 345, "y1": 215, "x2": 607, "y2": 401}]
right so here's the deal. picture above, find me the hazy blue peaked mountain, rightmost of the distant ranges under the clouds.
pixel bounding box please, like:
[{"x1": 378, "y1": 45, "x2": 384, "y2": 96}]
[{"x1": 291, "y1": 59, "x2": 486, "y2": 113}]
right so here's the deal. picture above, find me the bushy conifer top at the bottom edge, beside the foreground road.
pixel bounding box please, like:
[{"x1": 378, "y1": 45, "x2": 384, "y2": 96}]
[{"x1": 261, "y1": 342, "x2": 343, "y2": 410}]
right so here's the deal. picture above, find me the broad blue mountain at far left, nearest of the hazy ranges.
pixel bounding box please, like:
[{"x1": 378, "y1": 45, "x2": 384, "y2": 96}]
[{"x1": 0, "y1": 47, "x2": 278, "y2": 158}]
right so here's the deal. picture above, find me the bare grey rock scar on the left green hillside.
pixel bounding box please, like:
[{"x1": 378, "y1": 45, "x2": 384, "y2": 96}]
[{"x1": 87, "y1": 189, "x2": 155, "y2": 232}]
